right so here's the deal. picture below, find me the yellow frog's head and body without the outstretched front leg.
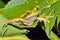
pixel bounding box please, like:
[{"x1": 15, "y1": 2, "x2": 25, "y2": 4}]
[{"x1": 6, "y1": 8, "x2": 38, "y2": 25}]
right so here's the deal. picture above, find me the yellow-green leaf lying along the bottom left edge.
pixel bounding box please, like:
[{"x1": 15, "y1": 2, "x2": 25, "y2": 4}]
[{"x1": 0, "y1": 35, "x2": 30, "y2": 40}]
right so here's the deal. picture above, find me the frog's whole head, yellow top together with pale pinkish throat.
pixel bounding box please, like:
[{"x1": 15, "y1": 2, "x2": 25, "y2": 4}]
[{"x1": 23, "y1": 8, "x2": 38, "y2": 25}]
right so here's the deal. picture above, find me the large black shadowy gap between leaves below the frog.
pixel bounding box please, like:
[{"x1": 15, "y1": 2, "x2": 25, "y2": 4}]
[{"x1": 27, "y1": 22, "x2": 49, "y2": 40}]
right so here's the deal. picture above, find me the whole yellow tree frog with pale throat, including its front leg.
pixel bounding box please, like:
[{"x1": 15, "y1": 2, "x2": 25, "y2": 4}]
[{"x1": 3, "y1": 7, "x2": 52, "y2": 25}]
